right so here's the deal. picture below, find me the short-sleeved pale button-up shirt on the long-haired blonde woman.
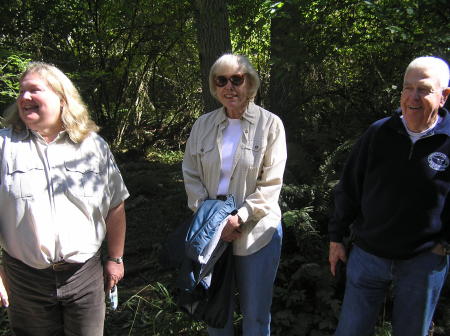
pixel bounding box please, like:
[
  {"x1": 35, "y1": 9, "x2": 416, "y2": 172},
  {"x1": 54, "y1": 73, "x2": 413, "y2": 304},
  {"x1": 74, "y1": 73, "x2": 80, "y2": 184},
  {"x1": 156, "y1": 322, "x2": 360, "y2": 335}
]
[{"x1": 0, "y1": 128, "x2": 129, "y2": 269}]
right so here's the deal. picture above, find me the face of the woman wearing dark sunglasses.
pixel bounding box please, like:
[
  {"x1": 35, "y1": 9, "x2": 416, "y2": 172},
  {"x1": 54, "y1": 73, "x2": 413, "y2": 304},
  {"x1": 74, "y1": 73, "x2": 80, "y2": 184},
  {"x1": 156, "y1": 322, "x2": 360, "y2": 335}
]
[{"x1": 214, "y1": 67, "x2": 248, "y2": 116}]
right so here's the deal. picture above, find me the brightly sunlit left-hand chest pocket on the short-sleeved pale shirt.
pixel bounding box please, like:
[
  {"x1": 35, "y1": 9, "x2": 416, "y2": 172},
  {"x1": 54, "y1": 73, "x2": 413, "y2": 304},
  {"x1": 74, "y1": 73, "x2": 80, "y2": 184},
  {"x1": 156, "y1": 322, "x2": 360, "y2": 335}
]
[{"x1": 6, "y1": 158, "x2": 48, "y2": 199}]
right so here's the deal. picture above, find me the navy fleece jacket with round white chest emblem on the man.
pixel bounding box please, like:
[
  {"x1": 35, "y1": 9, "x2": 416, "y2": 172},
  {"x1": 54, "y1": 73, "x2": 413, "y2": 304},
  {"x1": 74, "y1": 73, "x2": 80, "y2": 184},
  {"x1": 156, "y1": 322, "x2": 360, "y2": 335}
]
[{"x1": 329, "y1": 109, "x2": 450, "y2": 259}]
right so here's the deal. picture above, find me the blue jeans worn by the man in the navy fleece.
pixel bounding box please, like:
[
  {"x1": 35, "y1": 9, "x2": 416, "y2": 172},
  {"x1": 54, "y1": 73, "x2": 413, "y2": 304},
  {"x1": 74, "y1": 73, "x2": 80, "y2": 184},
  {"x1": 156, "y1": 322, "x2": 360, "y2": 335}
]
[{"x1": 335, "y1": 246, "x2": 448, "y2": 336}]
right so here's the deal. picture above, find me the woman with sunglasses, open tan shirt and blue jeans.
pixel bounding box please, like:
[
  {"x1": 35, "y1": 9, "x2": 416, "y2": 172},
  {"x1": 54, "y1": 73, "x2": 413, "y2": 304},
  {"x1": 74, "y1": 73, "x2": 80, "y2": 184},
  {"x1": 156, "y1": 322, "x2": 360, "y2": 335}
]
[{"x1": 183, "y1": 54, "x2": 286, "y2": 336}]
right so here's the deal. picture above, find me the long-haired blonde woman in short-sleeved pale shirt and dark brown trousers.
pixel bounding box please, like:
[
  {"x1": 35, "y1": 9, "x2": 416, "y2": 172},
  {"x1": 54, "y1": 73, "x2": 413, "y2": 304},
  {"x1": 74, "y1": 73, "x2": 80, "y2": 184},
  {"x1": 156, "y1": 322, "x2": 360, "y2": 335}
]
[{"x1": 0, "y1": 62, "x2": 128, "y2": 336}]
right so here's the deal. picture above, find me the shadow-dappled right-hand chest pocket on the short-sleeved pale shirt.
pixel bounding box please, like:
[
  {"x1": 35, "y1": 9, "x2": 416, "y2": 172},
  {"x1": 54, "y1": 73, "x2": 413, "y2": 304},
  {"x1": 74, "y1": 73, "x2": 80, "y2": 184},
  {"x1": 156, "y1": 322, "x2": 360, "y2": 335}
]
[{"x1": 64, "y1": 154, "x2": 105, "y2": 197}]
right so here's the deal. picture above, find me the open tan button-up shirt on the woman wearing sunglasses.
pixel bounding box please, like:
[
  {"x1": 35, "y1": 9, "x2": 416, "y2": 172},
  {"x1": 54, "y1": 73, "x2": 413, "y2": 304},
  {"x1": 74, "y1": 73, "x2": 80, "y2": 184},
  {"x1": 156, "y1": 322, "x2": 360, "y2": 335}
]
[{"x1": 183, "y1": 103, "x2": 287, "y2": 255}]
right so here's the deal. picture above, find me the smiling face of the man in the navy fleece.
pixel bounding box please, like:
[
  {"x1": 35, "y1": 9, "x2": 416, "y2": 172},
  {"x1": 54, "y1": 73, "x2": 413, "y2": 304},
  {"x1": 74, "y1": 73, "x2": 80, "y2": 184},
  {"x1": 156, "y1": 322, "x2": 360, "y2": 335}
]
[{"x1": 400, "y1": 68, "x2": 448, "y2": 132}]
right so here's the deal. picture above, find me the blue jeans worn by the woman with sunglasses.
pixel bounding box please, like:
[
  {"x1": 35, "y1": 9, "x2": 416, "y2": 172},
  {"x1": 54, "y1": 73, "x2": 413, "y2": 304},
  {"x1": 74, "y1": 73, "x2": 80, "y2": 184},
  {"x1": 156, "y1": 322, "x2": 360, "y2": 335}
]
[{"x1": 208, "y1": 223, "x2": 283, "y2": 336}]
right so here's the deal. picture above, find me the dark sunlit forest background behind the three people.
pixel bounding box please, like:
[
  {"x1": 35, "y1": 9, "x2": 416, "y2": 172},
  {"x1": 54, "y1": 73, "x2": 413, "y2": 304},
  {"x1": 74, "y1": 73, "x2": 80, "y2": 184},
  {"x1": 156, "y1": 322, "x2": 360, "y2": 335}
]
[{"x1": 0, "y1": 0, "x2": 450, "y2": 336}]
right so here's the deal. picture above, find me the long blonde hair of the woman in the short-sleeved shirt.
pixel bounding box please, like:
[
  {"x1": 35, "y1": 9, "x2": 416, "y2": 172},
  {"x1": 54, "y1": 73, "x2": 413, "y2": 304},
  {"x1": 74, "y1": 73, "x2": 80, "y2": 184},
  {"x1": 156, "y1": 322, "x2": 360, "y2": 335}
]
[{"x1": 5, "y1": 62, "x2": 99, "y2": 143}]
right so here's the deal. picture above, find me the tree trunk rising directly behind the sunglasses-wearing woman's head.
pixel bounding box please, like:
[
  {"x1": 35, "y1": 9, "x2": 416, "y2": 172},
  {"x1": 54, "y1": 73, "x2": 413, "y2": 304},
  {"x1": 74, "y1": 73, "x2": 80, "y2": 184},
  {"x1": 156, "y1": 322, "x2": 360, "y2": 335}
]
[{"x1": 193, "y1": 0, "x2": 231, "y2": 112}]
